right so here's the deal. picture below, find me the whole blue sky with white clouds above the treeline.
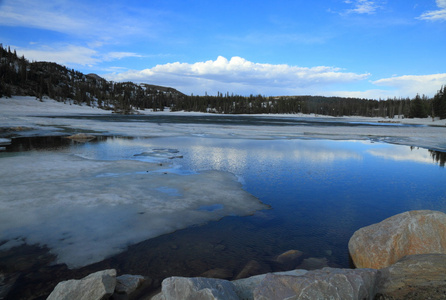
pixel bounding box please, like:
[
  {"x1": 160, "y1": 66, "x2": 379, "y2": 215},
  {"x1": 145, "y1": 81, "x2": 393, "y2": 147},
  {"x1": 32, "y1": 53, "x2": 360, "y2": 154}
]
[{"x1": 0, "y1": 0, "x2": 446, "y2": 99}]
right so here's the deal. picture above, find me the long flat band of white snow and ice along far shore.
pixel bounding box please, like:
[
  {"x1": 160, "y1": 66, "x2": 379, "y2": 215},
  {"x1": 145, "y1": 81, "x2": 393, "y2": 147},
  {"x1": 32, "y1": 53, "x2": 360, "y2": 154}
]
[{"x1": 0, "y1": 96, "x2": 446, "y2": 151}]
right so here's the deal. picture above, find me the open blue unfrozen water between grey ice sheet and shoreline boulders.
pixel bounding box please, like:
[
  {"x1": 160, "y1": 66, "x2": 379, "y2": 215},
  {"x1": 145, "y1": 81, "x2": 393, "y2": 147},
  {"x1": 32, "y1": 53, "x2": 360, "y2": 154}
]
[{"x1": 0, "y1": 136, "x2": 446, "y2": 298}]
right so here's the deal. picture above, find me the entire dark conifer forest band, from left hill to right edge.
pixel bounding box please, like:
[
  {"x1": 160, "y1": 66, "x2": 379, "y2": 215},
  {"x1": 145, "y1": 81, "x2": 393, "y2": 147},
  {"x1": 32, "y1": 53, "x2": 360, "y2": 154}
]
[{"x1": 0, "y1": 44, "x2": 446, "y2": 119}]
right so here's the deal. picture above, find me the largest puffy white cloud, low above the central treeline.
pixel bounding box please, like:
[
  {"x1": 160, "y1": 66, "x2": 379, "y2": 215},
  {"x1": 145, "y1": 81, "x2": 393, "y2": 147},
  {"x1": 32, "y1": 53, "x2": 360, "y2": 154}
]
[{"x1": 104, "y1": 56, "x2": 369, "y2": 94}]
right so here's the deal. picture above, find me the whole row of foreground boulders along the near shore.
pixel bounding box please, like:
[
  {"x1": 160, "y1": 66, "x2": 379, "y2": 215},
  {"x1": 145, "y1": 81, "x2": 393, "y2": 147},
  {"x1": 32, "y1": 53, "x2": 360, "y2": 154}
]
[{"x1": 43, "y1": 210, "x2": 446, "y2": 300}]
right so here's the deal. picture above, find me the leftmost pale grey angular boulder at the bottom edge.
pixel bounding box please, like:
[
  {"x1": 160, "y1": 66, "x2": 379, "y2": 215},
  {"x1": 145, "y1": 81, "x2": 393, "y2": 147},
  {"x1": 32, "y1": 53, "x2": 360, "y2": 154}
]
[{"x1": 47, "y1": 269, "x2": 116, "y2": 300}]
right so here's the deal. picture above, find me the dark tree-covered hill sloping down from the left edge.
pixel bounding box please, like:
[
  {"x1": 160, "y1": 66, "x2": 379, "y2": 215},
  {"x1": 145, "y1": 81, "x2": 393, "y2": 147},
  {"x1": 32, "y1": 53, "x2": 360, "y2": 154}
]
[{"x1": 0, "y1": 44, "x2": 186, "y2": 113}]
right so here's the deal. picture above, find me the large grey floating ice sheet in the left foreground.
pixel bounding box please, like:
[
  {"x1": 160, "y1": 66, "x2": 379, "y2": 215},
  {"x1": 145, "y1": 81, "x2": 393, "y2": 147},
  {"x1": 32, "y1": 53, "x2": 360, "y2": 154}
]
[{"x1": 0, "y1": 152, "x2": 267, "y2": 268}]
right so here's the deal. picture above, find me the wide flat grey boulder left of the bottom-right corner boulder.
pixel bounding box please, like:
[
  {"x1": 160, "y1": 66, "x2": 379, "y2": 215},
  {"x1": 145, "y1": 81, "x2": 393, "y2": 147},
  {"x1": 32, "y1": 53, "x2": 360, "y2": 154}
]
[{"x1": 254, "y1": 268, "x2": 378, "y2": 300}]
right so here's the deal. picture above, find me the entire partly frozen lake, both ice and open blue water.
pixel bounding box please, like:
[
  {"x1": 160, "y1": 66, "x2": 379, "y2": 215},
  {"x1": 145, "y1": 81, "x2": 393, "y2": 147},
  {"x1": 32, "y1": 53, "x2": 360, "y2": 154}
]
[{"x1": 0, "y1": 98, "x2": 446, "y2": 298}]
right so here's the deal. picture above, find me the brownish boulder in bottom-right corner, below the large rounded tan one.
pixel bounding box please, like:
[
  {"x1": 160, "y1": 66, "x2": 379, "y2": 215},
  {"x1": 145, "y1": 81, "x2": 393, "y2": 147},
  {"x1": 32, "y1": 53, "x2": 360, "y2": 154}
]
[{"x1": 376, "y1": 254, "x2": 446, "y2": 299}]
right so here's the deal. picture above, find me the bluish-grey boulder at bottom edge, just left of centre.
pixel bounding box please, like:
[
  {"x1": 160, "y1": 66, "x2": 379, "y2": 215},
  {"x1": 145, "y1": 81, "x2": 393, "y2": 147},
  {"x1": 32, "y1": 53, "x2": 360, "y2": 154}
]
[{"x1": 152, "y1": 277, "x2": 239, "y2": 300}]
